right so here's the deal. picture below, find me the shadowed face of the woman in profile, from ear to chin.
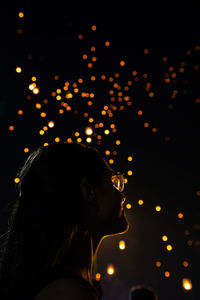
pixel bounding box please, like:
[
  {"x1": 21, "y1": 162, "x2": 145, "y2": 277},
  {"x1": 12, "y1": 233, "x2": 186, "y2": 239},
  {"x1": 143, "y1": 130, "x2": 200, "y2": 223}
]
[{"x1": 82, "y1": 164, "x2": 129, "y2": 237}]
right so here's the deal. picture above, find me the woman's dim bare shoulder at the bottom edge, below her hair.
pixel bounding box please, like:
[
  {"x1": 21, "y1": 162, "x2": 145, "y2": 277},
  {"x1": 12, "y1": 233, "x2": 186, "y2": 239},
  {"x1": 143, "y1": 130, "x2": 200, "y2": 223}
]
[{"x1": 34, "y1": 278, "x2": 98, "y2": 300}]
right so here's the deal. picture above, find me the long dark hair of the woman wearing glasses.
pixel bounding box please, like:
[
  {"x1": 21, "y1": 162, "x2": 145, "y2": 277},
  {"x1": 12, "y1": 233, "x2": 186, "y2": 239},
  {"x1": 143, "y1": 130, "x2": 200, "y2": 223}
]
[{"x1": 0, "y1": 142, "x2": 106, "y2": 300}]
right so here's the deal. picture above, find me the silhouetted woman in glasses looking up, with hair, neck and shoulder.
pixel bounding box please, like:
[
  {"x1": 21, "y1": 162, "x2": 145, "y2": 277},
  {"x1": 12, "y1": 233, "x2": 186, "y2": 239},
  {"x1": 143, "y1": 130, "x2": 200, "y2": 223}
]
[{"x1": 0, "y1": 142, "x2": 129, "y2": 300}]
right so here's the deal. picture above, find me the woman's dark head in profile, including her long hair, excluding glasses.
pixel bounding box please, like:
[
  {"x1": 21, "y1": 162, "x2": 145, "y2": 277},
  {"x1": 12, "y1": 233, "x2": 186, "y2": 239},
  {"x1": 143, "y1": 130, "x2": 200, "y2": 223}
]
[{"x1": 0, "y1": 142, "x2": 128, "y2": 298}]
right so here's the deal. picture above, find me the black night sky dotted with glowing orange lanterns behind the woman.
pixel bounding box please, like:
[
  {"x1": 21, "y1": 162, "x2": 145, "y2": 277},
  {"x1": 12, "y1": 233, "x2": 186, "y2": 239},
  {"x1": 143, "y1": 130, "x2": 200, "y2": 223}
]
[{"x1": 0, "y1": 5, "x2": 200, "y2": 300}]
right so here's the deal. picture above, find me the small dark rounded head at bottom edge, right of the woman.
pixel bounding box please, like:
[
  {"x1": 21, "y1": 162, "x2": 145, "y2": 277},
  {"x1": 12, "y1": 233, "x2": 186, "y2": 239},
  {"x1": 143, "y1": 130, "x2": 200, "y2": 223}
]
[{"x1": 129, "y1": 285, "x2": 158, "y2": 300}]
